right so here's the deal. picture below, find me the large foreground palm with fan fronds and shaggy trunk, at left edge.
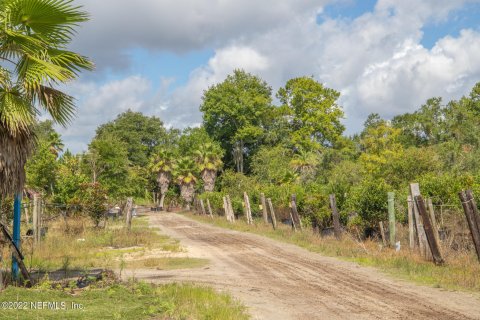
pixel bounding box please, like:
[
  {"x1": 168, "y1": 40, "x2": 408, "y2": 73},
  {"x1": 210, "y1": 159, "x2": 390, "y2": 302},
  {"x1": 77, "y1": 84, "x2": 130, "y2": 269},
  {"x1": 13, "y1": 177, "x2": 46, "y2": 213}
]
[{"x1": 0, "y1": 0, "x2": 93, "y2": 195}]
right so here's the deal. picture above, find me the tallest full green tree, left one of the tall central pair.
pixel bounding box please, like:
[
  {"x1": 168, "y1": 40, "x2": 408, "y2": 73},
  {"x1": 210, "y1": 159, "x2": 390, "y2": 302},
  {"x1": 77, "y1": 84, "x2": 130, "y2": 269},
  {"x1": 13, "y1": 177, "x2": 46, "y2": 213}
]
[{"x1": 200, "y1": 70, "x2": 272, "y2": 172}]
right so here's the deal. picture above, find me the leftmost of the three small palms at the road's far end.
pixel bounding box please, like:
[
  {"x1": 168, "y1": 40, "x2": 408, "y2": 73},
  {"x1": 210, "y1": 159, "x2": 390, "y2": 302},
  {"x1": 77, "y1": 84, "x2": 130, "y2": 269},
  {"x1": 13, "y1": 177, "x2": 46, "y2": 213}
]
[{"x1": 149, "y1": 149, "x2": 175, "y2": 210}]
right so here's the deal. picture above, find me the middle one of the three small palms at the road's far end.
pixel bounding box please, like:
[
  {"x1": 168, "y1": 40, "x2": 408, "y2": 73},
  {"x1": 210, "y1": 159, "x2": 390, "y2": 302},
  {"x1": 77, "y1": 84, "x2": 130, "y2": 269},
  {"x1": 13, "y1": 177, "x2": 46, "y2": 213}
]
[{"x1": 175, "y1": 157, "x2": 197, "y2": 210}]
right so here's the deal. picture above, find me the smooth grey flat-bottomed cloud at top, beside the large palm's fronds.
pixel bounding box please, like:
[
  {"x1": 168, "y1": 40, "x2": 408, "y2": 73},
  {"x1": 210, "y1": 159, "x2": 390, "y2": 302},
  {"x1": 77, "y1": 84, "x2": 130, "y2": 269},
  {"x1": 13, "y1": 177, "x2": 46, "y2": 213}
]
[{"x1": 74, "y1": 0, "x2": 327, "y2": 68}]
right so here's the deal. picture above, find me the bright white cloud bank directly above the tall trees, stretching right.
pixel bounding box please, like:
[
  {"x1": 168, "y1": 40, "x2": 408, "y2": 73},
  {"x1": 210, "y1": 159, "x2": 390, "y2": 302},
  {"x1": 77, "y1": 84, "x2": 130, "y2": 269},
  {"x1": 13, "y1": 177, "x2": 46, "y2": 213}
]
[{"x1": 160, "y1": 0, "x2": 480, "y2": 132}]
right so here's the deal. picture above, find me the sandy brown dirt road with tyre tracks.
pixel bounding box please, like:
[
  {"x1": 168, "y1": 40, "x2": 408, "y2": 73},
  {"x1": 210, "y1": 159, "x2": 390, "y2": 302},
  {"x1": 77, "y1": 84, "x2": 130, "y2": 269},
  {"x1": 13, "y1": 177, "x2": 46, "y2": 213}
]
[{"x1": 124, "y1": 213, "x2": 480, "y2": 320}]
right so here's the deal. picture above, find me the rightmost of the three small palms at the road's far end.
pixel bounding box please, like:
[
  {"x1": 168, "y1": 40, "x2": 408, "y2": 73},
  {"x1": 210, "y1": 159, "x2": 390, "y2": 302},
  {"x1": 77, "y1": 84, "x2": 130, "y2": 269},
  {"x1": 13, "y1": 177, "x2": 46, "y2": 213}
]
[{"x1": 195, "y1": 142, "x2": 223, "y2": 192}]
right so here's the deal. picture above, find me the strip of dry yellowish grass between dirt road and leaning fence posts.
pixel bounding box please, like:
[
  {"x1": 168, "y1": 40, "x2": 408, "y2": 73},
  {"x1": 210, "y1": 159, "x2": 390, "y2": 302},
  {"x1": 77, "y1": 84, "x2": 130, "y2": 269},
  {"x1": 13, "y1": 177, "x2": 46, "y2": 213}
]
[{"x1": 187, "y1": 214, "x2": 480, "y2": 292}]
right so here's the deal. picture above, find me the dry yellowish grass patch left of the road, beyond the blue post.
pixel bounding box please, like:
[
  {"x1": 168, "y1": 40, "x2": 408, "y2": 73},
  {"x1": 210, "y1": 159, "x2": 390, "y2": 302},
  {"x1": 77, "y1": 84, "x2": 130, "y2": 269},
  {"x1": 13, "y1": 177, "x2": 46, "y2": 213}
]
[{"x1": 3, "y1": 217, "x2": 206, "y2": 276}]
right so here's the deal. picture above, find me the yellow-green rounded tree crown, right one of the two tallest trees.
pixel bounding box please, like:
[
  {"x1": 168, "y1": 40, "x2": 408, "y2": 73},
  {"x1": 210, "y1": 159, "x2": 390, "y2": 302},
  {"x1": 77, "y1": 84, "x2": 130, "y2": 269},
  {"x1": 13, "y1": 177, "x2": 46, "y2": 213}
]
[{"x1": 277, "y1": 77, "x2": 345, "y2": 151}]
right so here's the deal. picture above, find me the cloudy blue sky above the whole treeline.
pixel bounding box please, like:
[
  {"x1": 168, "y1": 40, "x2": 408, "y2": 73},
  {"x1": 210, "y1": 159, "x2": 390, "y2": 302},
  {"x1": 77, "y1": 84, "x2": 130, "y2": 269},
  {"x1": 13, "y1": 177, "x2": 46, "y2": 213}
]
[{"x1": 59, "y1": 0, "x2": 480, "y2": 152}]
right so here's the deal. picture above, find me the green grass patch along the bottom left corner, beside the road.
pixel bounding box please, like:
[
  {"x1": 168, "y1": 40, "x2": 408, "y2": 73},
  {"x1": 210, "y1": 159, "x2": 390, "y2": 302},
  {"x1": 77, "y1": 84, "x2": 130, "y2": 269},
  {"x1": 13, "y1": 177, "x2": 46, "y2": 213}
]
[{"x1": 0, "y1": 282, "x2": 249, "y2": 320}]
